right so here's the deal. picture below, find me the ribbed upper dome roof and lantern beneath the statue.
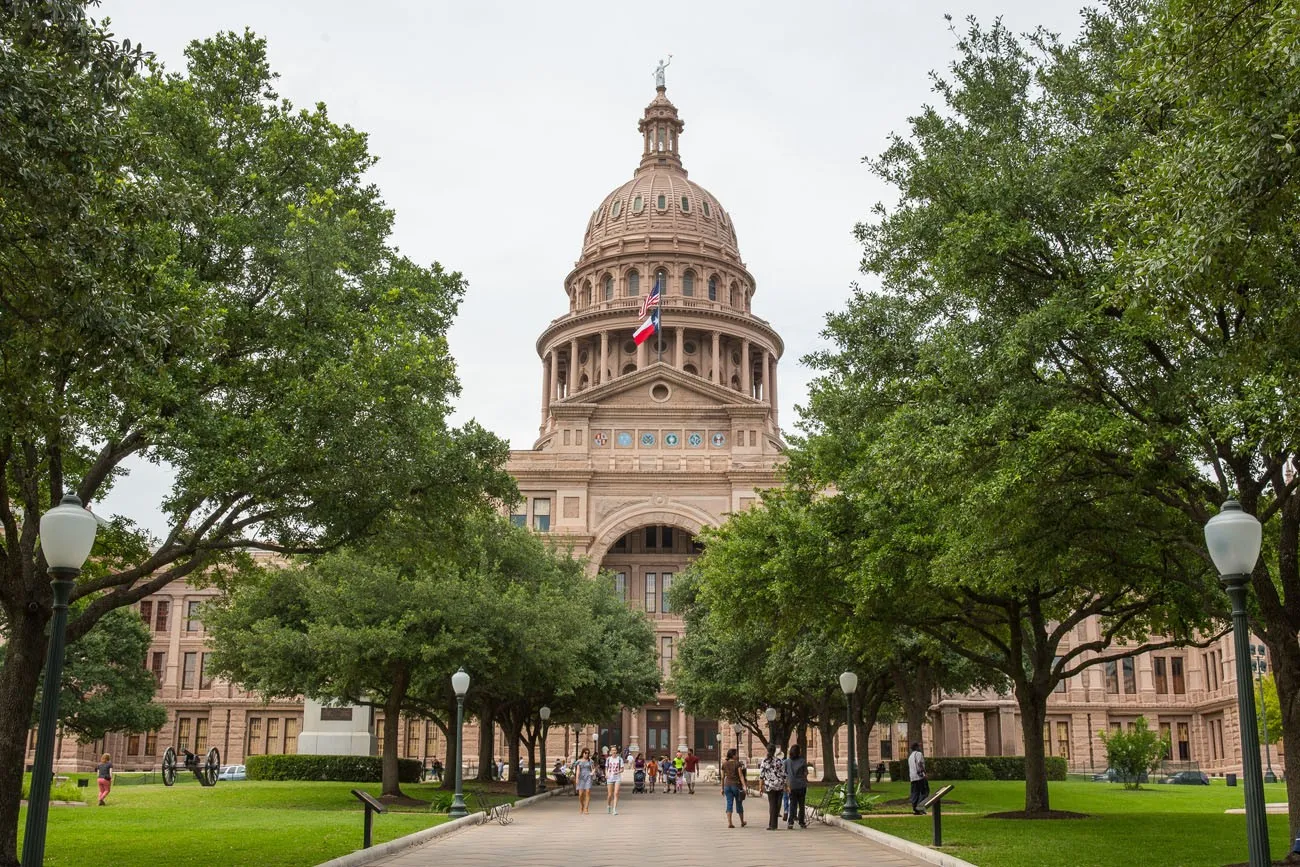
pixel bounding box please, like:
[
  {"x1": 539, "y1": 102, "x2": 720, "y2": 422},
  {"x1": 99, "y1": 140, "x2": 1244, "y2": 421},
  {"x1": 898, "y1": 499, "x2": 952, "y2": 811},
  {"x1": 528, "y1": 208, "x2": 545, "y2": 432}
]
[{"x1": 582, "y1": 87, "x2": 740, "y2": 259}]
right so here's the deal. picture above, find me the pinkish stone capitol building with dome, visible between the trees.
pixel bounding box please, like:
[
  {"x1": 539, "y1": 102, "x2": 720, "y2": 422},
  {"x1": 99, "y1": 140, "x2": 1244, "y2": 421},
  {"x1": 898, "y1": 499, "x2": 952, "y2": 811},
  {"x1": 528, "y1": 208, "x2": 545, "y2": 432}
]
[{"x1": 29, "y1": 79, "x2": 1282, "y2": 773}]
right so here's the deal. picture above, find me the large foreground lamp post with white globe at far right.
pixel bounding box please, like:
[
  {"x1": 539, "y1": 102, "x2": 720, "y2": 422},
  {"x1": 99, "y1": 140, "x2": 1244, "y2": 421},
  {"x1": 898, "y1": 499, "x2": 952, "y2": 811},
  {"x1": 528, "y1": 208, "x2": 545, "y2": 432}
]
[{"x1": 1205, "y1": 499, "x2": 1273, "y2": 867}]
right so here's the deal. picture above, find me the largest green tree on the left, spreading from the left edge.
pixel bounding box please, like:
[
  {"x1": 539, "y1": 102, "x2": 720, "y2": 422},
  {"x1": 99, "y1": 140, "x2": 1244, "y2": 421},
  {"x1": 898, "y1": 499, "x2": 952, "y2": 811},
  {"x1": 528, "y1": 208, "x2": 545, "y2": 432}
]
[{"x1": 0, "y1": 13, "x2": 506, "y2": 864}]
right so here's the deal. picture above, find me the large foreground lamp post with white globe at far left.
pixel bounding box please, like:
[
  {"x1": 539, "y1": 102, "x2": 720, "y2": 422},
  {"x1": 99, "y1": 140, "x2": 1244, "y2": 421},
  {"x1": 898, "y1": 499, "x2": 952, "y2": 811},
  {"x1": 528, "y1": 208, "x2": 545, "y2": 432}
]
[{"x1": 22, "y1": 493, "x2": 99, "y2": 867}]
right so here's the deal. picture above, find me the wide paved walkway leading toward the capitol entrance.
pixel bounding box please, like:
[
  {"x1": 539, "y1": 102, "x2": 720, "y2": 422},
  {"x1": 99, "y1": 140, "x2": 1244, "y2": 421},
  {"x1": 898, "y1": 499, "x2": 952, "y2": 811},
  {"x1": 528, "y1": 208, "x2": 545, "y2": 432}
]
[{"x1": 373, "y1": 785, "x2": 923, "y2": 867}]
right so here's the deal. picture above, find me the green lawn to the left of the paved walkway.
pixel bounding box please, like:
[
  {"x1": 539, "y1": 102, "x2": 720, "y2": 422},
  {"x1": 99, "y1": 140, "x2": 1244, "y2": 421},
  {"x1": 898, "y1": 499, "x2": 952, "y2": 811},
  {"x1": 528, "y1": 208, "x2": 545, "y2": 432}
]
[{"x1": 18, "y1": 779, "x2": 501, "y2": 867}]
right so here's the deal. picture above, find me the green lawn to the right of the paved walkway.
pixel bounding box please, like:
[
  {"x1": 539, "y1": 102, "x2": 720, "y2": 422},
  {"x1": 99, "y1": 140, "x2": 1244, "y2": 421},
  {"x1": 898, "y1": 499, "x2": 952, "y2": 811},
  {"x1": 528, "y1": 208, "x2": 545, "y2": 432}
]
[{"x1": 809, "y1": 780, "x2": 1291, "y2": 867}]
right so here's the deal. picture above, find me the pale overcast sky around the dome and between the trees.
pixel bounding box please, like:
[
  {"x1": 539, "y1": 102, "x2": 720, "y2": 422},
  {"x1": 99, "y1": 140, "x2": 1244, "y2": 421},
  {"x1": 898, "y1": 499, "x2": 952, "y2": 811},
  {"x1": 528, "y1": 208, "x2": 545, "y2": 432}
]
[{"x1": 92, "y1": 0, "x2": 1080, "y2": 536}]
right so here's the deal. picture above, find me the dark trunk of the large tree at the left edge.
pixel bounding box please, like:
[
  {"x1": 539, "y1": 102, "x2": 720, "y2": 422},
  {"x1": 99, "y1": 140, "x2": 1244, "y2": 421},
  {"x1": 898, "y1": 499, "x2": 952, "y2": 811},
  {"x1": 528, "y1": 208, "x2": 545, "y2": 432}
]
[{"x1": 0, "y1": 613, "x2": 48, "y2": 867}]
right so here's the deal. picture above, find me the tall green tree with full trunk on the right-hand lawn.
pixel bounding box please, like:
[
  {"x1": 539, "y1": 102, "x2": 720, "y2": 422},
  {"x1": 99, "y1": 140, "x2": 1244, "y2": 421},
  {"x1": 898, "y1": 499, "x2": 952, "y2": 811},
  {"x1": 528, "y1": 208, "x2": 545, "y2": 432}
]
[{"x1": 803, "y1": 4, "x2": 1222, "y2": 812}]
